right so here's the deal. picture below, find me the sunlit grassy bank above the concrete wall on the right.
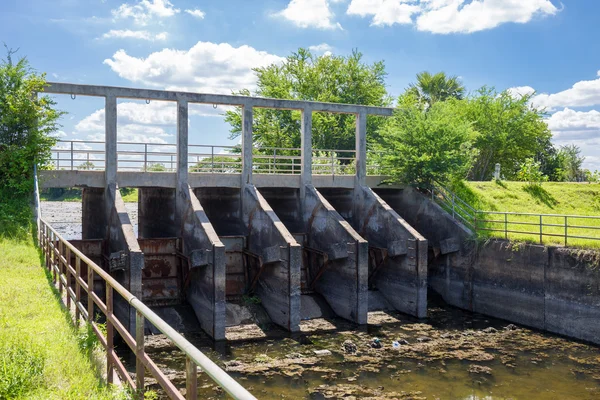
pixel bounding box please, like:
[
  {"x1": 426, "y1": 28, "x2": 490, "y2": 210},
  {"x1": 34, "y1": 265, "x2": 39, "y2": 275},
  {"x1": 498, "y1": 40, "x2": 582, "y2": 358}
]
[{"x1": 453, "y1": 182, "x2": 600, "y2": 248}]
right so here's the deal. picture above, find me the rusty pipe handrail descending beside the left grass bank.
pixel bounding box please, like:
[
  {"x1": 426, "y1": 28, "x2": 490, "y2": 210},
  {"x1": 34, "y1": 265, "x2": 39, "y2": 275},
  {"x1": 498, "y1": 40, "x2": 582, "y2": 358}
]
[{"x1": 36, "y1": 220, "x2": 255, "y2": 400}]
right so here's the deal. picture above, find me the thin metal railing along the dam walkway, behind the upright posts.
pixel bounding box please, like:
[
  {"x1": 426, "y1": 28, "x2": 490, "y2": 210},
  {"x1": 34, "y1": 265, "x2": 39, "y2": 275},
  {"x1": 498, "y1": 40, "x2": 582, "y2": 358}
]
[{"x1": 51, "y1": 140, "x2": 385, "y2": 175}]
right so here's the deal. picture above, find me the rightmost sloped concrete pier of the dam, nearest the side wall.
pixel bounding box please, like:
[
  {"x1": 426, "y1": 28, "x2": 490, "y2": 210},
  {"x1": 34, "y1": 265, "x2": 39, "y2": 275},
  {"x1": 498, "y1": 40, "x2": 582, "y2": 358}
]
[{"x1": 319, "y1": 186, "x2": 427, "y2": 318}]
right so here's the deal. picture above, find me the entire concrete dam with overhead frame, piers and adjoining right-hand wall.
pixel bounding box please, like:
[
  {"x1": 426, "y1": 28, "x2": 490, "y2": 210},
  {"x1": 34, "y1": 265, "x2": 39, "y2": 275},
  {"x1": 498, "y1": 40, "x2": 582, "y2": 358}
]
[{"x1": 39, "y1": 83, "x2": 600, "y2": 344}]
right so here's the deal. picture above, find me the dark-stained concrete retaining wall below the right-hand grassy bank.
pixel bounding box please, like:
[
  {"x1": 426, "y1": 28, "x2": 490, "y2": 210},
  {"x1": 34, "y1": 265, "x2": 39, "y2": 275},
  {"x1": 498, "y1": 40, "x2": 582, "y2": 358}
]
[{"x1": 472, "y1": 240, "x2": 600, "y2": 344}]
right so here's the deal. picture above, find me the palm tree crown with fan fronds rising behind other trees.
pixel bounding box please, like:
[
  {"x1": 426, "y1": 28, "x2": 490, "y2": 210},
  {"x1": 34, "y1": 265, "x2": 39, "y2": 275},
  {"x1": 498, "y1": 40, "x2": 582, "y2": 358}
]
[{"x1": 407, "y1": 71, "x2": 465, "y2": 108}]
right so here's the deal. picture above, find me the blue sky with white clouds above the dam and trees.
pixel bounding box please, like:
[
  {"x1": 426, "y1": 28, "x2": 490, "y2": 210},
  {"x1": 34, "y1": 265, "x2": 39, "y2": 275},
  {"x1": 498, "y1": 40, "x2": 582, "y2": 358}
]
[{"x1": 0, "y1": 0, "x2": 600, "y2": 170}]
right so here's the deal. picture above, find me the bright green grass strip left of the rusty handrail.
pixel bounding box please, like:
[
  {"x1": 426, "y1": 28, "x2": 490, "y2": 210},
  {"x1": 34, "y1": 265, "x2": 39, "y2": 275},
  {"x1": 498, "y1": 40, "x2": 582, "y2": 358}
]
[{"x1": 0, "y1": 191, "x2": 122, "y2": 399}]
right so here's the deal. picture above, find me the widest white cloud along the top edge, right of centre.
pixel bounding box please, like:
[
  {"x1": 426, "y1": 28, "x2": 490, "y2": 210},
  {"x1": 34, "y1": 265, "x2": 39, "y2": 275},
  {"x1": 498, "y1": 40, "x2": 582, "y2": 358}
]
[{"x1": 346, "y1": 0, "x2": 558, "y2": 34}]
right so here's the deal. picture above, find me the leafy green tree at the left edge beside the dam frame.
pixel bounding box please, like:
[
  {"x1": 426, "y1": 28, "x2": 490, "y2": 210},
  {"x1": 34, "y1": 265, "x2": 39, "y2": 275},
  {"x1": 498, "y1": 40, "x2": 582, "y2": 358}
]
[{"x1": 0, "y1": 50, "x2": 62, "y2": 193}]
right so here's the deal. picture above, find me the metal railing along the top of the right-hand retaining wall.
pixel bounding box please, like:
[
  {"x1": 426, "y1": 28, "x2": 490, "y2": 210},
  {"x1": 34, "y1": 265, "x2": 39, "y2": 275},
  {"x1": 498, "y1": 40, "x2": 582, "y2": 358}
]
[{"x1": 428, "y1": 184, "x2": 600, "y2": 246}]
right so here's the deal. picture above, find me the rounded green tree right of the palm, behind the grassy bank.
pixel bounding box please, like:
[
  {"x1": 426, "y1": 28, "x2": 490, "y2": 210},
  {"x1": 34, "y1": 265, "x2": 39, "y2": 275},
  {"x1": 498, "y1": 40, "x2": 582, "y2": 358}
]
[{"x1": 464, "y1": 86, "x2": 552, "y2": 181}]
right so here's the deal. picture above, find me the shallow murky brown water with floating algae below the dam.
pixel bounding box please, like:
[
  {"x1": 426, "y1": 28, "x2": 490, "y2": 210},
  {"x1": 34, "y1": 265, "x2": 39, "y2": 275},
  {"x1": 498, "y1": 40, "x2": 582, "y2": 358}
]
[{"x1": 144, "y1": 306, "x2": 600, "y2": 400}]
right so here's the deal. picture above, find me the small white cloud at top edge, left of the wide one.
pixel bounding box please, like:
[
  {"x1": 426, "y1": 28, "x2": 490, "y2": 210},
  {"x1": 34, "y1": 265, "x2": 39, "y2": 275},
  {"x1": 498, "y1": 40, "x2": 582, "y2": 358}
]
[{"x1": 273, "y1": 0, "x2": 342, "y2": 29}]
